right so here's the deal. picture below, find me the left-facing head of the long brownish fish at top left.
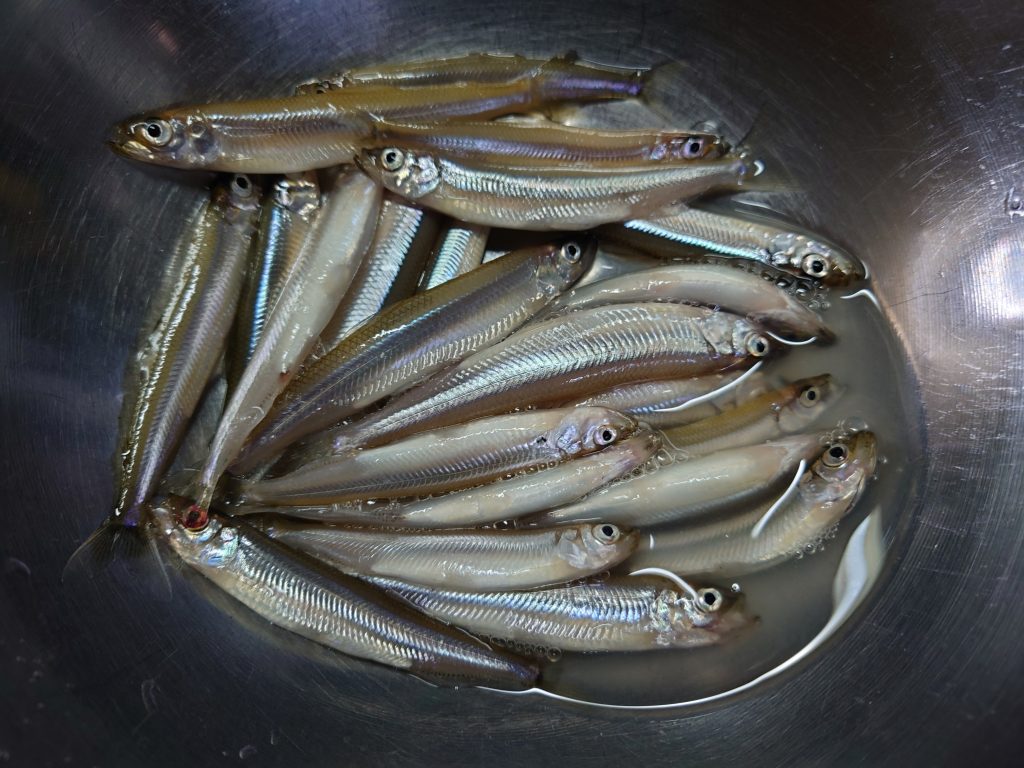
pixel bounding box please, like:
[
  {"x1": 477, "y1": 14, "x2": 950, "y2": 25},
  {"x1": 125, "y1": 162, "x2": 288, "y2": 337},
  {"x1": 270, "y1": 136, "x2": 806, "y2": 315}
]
[{"x1": 109, "y1": 109, "x2": 220, "y2": 168}]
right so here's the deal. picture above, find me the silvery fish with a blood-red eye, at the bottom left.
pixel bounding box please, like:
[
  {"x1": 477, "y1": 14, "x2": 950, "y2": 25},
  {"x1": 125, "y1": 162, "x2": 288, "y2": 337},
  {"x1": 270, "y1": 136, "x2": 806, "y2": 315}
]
[{"x1": 145, "y1": 498, "x2": 540, "y2": 690}]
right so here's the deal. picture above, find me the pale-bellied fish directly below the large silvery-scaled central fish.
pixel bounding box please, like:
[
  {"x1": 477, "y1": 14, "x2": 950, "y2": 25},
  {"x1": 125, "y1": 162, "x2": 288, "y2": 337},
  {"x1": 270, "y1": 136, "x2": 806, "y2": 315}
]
[{"x1": 241, "y1": 408, "x2": 637, "y2": 505}]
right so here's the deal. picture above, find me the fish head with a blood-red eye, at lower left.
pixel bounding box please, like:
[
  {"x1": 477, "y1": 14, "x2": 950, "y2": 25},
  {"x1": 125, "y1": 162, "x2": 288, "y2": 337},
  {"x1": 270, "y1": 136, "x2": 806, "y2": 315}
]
[{"x1": 145, "y1": 496, "x2": 239, "y2": 567}]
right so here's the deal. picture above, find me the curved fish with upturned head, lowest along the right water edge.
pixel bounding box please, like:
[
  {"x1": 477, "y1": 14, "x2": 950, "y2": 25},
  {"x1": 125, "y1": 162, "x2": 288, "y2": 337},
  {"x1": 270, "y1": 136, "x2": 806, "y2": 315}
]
[{"x1": 629, "y1": 432, "x2": 878, "y2": 578}]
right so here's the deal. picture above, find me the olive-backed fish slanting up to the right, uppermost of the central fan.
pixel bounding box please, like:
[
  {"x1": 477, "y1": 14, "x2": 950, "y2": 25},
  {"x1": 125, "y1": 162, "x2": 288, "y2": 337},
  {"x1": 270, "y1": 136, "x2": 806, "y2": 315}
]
[{"x1": 227, "y1": 241, "x2": 591, "y2": 472}]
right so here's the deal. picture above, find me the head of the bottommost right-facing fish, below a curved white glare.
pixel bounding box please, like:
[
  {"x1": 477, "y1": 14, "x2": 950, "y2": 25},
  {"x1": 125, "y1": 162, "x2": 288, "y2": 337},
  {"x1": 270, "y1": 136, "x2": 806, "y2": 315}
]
[{"x1": 650, "y1": 586, "x2": 757, "y2": 647}]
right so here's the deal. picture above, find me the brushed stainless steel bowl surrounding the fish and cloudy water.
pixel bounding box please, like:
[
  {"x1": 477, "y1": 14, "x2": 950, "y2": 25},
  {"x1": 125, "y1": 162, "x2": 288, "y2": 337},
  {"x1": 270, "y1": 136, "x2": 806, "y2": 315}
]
[{"x1": 0, "y1": 0, "x2": 1024, "y2": 766}]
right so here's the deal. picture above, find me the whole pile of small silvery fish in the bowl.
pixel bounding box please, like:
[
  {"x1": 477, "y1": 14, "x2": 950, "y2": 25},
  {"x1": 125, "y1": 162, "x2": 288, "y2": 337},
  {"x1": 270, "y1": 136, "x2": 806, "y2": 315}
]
[{"x1": 105, "y1": 54, "x2": 876, "y2": 689}]
